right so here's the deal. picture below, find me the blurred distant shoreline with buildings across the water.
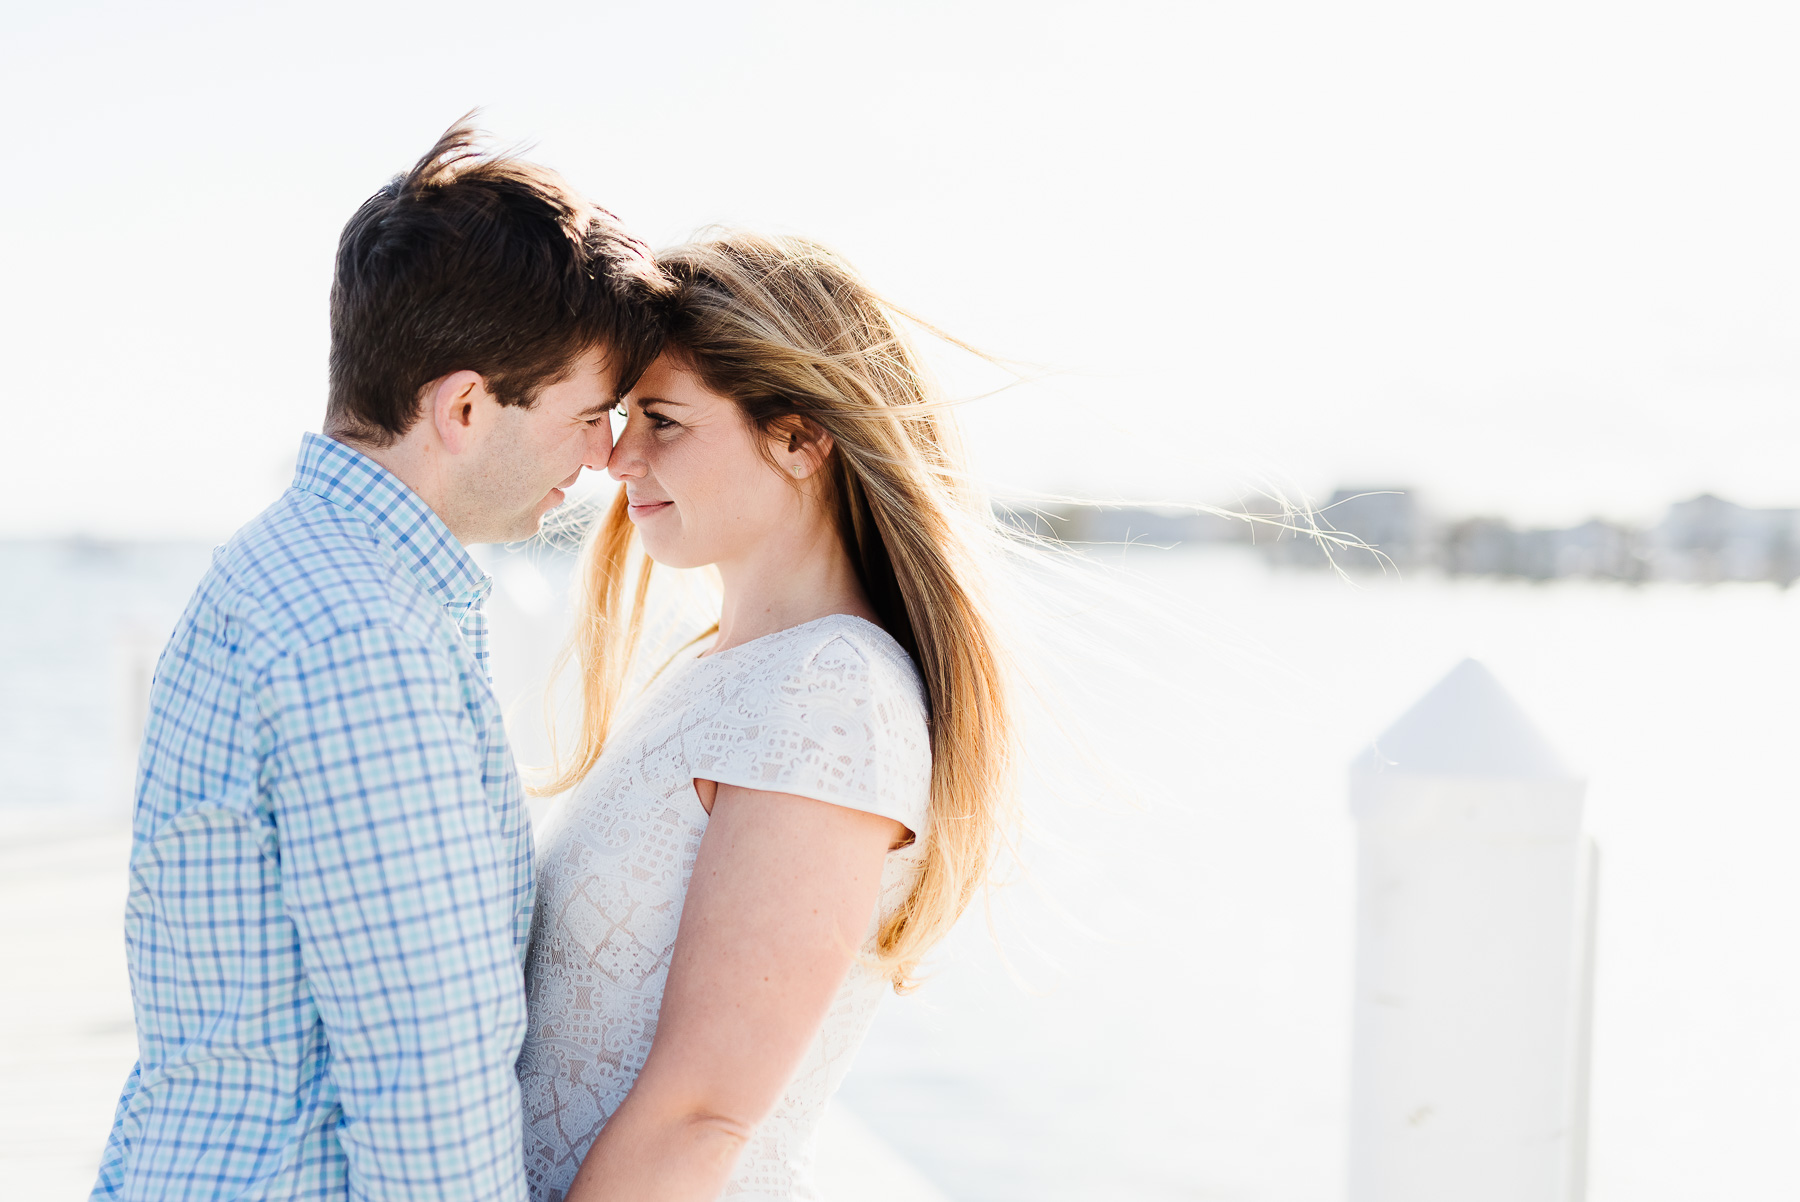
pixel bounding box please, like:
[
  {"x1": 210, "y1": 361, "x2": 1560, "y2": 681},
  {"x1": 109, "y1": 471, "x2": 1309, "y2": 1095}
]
[{"x1": 1003, "y1": 488, "x2": 1800, "y2": 588}]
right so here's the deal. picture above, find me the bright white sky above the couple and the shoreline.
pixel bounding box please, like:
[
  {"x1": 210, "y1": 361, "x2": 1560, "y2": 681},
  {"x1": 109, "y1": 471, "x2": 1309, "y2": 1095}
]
[{"x1": 0, "y1": 0, "x2": 1800, "y2": 536}]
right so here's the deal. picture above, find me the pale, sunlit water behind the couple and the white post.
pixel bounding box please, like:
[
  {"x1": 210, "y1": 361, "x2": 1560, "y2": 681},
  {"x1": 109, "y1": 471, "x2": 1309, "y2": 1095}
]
[{"x1": 0, "y1": 543, "x2": 1800, "y2": 1202}]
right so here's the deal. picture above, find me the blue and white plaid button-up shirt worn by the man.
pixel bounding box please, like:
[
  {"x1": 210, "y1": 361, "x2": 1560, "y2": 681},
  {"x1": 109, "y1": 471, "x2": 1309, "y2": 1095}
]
[{"x1": 94, "y1": 435, "x2": 533, "y2": 1202}]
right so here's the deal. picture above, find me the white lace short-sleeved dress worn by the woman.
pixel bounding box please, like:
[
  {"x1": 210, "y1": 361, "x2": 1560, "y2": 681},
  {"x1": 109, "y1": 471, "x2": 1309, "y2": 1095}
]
[{"x1": 518, "y1": 614, "x2": 931, "y2": 1202}]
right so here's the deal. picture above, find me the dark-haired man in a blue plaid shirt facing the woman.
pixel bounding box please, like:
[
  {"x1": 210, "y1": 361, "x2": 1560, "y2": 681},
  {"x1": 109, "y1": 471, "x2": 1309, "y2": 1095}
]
[{"x1": 94, "y1": 126, "x2": 666, "y2": 1202}]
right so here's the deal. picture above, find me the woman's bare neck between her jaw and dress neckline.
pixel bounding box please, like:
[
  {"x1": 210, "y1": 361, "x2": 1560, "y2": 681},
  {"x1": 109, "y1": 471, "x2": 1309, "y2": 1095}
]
[{"x1": 713, "y1": 524, "x2": 877, "y2": 651}]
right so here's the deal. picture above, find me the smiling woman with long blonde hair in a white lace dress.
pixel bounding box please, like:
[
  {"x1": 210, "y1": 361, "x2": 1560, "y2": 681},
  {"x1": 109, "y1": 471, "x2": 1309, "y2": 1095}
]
[{"x1": 518, "y1": 234, "x2": 1013, "y2": 1202}]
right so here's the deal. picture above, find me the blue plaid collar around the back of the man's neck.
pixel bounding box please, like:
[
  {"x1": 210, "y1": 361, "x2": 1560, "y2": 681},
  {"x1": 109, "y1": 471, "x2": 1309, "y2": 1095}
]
[{"x1": 293, "y1": 434, "x2": 493, "y2": 608}]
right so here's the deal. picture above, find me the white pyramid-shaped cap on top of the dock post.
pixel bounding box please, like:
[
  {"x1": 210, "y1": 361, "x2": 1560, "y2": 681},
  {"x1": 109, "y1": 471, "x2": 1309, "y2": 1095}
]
[{"x1": 1352, "y1": 659, "x2": 1580, "y2": 783}]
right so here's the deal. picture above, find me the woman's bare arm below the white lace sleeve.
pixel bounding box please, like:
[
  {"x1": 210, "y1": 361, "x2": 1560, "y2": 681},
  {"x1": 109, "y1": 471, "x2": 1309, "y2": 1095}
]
[{"x1": 567, "y1": 781, "x2": 905, "y2": 1202}]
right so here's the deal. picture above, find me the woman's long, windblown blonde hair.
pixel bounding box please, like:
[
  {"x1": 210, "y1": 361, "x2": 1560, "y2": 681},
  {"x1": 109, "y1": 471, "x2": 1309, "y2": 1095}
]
[{"x1": 545, "y1": 232, "x2": 1017, "y2": 990}]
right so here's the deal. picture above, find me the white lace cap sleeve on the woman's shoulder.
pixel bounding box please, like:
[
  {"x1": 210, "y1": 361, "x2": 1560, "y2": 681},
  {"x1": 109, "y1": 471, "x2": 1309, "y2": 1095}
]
[{"x1": 684, "y1": 617, "x2": 931, "y2": 839}]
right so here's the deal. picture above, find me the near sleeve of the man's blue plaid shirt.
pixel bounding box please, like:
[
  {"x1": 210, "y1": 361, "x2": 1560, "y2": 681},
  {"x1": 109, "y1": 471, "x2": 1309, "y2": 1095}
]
[{"x1": 270, "y1": 626, "x2": 526, "y2": 1202}]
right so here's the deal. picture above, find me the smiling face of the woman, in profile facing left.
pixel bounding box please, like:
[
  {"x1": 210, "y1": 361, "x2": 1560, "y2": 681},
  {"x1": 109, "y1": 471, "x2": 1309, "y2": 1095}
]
[{"x1": 607, "y1": 354, "x2": 812, "y2": 567}]
